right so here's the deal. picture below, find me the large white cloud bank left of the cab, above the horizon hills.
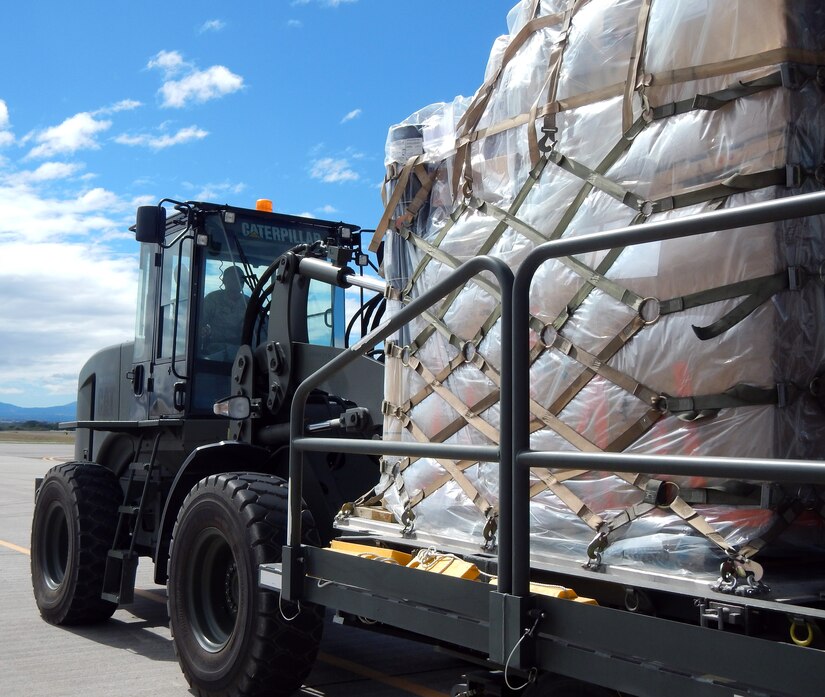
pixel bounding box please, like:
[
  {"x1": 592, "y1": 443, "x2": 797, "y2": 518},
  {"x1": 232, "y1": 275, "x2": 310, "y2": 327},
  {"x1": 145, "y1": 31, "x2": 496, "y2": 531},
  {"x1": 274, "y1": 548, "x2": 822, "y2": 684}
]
[{"x1": 0, "y1": 177, "x2": 137, "y2": 404}]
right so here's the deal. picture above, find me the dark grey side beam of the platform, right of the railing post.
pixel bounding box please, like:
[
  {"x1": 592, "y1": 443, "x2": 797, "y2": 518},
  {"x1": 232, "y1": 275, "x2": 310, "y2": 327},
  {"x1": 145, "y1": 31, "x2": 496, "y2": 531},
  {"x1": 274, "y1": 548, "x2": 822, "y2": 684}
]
[{"x1": 536, "y1": 598, "x2": 825, "y2": 697}]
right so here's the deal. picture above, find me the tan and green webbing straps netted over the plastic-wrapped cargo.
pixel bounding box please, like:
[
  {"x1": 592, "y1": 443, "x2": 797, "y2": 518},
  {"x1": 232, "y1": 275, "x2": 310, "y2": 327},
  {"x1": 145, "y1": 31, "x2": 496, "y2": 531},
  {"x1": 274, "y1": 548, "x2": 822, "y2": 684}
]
[{"x1": 374, "y1": 28, "x2": 825, "y2": 553}]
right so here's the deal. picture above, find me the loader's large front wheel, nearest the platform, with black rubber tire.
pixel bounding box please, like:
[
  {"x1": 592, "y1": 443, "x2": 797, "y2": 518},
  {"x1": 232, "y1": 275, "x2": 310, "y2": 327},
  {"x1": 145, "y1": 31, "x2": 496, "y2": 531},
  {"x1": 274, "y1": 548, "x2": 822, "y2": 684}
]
[{"x1": 168, "y1": 473, "x2": 324, "y2": 697}]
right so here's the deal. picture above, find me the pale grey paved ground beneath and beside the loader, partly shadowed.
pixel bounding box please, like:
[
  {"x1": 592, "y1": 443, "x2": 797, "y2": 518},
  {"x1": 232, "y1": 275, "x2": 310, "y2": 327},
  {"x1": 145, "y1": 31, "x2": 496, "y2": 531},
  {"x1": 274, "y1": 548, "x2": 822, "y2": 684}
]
[{"x1": 0, "y1": 443, "x2": 468, "y2": 697}]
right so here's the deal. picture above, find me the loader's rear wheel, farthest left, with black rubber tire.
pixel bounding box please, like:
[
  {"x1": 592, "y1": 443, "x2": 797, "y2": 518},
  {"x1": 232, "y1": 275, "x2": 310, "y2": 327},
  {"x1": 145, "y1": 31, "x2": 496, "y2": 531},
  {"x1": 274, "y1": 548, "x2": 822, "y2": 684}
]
[{"x1": 31, "y1": 462, "x2": 123, "y2": 625}]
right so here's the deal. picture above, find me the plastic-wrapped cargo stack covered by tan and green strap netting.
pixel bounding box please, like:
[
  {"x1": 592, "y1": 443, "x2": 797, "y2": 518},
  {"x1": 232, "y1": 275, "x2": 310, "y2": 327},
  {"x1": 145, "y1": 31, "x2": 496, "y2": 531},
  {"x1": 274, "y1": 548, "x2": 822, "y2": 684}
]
[{"x1": 358, "y1": 0, "x2": 825, "y2": 592}]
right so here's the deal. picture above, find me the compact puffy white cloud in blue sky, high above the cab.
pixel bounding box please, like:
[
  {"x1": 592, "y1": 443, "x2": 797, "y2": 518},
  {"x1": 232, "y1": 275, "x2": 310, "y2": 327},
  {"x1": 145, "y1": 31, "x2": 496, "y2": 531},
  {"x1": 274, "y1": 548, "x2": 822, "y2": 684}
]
[{"x1": 147, "y1": 51, "x2": 244, "y2": 109}]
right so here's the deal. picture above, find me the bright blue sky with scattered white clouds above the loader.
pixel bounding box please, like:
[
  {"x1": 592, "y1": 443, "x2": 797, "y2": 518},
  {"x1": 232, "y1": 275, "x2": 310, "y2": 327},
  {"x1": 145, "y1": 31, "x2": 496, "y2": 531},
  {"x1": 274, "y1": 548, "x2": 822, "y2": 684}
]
[{"x1": 0, "y1": 0, "x2": 515, "y2": 406}]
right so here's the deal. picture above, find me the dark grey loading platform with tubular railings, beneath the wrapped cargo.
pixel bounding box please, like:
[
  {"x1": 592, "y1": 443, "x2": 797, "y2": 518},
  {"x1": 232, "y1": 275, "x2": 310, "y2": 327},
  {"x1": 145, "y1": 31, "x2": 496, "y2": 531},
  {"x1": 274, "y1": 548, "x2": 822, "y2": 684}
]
[{"x1": 260, "y1": 193, "x2": 825, "y2": 697}]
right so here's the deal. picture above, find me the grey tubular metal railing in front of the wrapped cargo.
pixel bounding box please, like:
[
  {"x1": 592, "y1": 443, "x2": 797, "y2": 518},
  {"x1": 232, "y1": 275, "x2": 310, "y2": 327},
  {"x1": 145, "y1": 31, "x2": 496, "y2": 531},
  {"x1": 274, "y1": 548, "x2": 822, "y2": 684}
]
[{"x1": 287, "y1": 192, "x2": 825, "y2": 597}]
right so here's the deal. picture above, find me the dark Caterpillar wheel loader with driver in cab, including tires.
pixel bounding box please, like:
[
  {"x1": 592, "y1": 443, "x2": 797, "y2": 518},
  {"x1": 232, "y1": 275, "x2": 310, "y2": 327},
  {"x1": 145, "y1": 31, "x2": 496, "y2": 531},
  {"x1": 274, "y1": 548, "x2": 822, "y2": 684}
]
[{"x1": 32, "y1": 200, "x2": 384, "y2": 695}]
